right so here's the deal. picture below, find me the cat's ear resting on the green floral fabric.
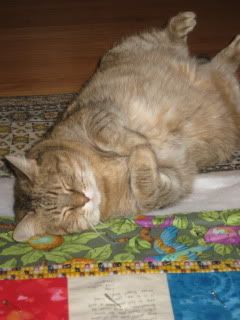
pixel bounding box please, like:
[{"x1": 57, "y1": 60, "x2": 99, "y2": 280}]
[{"x1": 13, "y1": 212, "x2": 44, "y2": 242}]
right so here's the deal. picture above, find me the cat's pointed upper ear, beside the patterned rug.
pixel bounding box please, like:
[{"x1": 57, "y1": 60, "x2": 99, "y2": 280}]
[{"x1": 5, "y1": 156, "x2": 38, "y2": 181}]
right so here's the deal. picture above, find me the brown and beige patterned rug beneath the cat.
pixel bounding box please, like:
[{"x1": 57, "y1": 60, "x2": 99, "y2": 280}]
[{"x1": 0, "y1": 93, "x2": 240, "y2": 176}]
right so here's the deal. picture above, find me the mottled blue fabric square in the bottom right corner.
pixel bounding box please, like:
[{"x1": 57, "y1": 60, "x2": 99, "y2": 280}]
[{"x1": 168, "y1": 272, "x2": 240, "y2": 320}]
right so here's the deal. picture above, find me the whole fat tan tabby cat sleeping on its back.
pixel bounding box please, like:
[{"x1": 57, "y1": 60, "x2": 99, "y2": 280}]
[{"x1": 7, "y1": 12, "x2": 240, "y2": 241}]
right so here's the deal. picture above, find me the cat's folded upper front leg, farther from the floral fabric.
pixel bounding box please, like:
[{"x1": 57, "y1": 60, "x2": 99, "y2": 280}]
[{"x1": 83, "y1": 108, "x2": 147, "y2": 156}]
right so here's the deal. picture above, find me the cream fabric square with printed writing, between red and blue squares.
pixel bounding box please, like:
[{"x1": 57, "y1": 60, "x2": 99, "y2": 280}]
[{"x1": 68, "y1": 274, "x2": 174, "y2": 320}]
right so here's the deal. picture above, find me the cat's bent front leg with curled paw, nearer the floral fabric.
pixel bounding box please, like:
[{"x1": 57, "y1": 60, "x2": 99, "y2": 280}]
[{"x1": 128, "y1": 145, "x2": 192, "y2": 211}]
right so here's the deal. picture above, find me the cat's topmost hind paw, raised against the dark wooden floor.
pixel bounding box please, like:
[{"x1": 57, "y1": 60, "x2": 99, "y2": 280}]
[{"x1": 168, "y1": 11, "x2": 197, "y2": 39}]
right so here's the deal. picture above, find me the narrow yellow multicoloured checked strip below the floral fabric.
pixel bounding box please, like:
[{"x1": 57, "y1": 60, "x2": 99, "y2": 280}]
[{"x1": 0, "y1": 259, "x2": 240, "y2": 280}]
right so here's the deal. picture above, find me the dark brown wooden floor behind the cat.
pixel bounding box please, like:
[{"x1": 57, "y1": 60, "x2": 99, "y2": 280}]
[{"x1": 0, "y1": 0, "x2": 240, "y2": 96}]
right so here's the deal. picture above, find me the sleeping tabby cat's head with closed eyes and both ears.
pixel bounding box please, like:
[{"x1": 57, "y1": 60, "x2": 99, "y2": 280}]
[{"x1": 7, "y1": 141, "x2": 101, "y2": 241}]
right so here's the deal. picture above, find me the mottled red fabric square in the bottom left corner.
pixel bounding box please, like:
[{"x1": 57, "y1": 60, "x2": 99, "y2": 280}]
[{"x1": 0, "y1": 278, "x2": 68, "y2": 320}]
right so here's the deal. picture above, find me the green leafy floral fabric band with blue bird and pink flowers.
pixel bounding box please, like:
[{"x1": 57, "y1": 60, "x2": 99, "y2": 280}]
[{"x1": 0, "y1": 210, "x2": 240, "y2": 270}]
